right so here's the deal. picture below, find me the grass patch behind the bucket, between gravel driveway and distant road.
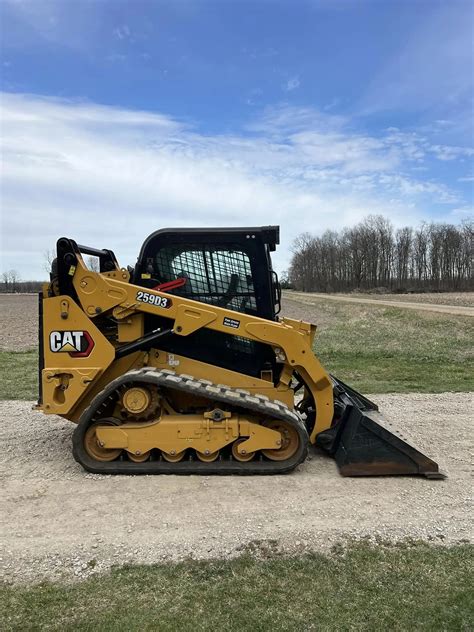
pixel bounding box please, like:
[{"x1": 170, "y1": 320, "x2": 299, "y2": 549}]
[{"x1": 314, "y1": 300, "x2": 474, "y2": 393}]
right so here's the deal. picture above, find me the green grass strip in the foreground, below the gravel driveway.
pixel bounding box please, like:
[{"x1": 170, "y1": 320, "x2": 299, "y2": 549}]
[{"x1": 0, "y1": 544, "x2": 474, "y2": 632}]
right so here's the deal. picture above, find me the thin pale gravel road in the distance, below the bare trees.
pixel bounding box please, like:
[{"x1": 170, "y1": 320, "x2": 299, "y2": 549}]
[{"x1": 284, "y1": 291, "x2": 474, "y2": 317}]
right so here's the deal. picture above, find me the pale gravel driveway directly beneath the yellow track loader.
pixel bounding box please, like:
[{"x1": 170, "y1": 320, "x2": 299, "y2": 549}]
[{"x1": 0, "y1": 393, "x2": 474, "y2": 582}]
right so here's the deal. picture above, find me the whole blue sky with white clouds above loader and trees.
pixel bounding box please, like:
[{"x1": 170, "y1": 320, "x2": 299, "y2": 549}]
[{"x1": 0, "y1": 0, "x2": 474, "y2": 278}]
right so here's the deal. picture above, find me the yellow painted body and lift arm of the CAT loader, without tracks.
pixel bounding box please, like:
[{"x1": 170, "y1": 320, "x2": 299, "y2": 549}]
[{"x1": 39, "y1": 256, "x2": 334, "y2": 443}]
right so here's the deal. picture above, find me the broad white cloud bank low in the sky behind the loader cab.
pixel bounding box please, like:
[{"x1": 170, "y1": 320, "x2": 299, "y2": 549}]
[{"x1": 0, "y1": 93, "x2": 463, "y2": 278}]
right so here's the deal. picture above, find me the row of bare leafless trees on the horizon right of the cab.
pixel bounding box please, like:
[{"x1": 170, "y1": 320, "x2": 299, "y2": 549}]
[{"x1": 288, "y1": 215, "x2": 474, "y2": 292}]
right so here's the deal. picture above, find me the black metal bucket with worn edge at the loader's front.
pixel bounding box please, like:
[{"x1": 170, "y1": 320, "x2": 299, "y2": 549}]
[{"x1": 316, "y1": 376, "x2": 446, "y2": 479}]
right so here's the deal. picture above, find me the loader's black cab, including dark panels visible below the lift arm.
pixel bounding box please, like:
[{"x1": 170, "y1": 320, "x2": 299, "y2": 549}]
[{"x1": 132, "y1": 226, "x2": 281, "y2": 380}]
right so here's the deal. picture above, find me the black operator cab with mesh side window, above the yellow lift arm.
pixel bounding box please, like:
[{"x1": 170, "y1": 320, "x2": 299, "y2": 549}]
[{"x1": 133, "y1": 226, "x2": 280, "y2": 320}]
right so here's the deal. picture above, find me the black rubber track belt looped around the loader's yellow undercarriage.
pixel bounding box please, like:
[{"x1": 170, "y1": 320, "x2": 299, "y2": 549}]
[{"x1": 72, "y1": 367, "x2": 309, "y2": 475}]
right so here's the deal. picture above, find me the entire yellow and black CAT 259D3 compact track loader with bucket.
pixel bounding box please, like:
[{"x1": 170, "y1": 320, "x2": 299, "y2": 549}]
[{"x1": 38, "y1": 226, "x2": 443, "y2": 478}]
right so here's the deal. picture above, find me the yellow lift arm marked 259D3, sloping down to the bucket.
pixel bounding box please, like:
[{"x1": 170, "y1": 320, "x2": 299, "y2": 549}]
[{"x1": 68, "y1": 249, "x2": 334, "y2": 442}]
